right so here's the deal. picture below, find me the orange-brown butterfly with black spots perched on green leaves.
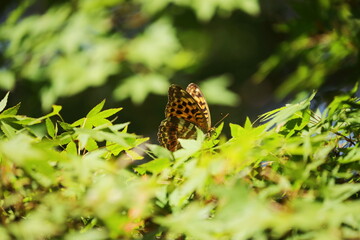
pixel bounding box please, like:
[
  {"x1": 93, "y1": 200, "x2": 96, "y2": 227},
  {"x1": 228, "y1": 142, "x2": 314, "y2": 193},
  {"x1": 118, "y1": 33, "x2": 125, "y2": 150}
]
[{"x1": 158, "y1": 83, "x2": 211, "y2": 151}]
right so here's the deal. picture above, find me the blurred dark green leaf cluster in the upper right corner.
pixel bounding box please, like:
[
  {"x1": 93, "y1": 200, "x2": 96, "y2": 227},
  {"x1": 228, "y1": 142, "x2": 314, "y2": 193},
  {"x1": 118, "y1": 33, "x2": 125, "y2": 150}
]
[{"x1": 253, "y1": 0, "x2": 360, "y2": 98}]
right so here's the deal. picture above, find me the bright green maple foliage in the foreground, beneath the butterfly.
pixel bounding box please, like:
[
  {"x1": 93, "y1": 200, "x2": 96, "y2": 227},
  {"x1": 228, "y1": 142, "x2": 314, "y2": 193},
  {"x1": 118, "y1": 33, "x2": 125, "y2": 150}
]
[{"x1": 0, "y1": 85, "x2": 360, "y2": 240}]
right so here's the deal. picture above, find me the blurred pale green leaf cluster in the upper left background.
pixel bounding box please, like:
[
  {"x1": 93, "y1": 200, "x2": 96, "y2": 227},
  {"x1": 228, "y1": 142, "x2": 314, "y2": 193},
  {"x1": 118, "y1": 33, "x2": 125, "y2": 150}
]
[{"x1": 0, "y1": 0, "x2": 246, "y2": 110}]
